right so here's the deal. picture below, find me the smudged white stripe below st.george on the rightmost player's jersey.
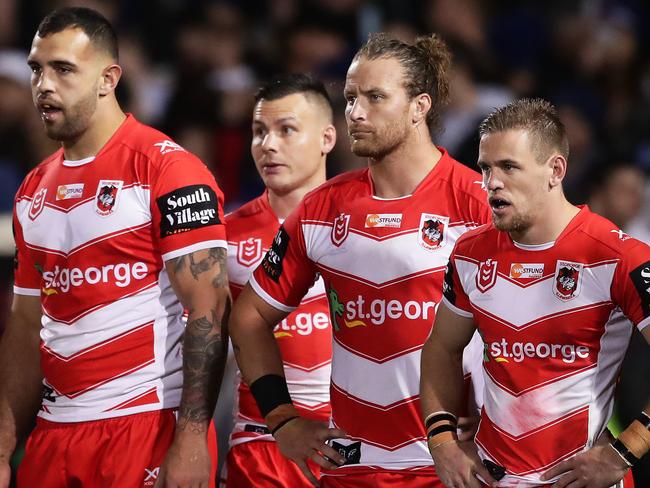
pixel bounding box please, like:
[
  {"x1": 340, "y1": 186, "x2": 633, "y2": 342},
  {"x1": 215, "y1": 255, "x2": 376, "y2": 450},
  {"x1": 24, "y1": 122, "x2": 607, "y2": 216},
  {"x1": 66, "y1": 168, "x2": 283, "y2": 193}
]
[{"x1": 483, "y1": 364, "x2": 595, "y2": 439}]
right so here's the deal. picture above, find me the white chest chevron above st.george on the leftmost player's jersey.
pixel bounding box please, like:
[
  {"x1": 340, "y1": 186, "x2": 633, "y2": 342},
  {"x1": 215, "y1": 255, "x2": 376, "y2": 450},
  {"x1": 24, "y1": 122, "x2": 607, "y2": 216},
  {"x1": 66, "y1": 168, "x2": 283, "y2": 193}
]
[{"x1": 16, "y1": 186, "x2": 151, "y2": 254}]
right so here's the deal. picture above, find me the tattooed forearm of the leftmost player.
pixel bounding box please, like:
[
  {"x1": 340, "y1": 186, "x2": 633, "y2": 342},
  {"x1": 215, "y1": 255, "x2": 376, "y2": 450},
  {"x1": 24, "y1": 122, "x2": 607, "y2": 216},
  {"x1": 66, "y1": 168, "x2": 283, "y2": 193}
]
[{"x1": 178, "y1": 294, "x2": 230, "y2": 434}]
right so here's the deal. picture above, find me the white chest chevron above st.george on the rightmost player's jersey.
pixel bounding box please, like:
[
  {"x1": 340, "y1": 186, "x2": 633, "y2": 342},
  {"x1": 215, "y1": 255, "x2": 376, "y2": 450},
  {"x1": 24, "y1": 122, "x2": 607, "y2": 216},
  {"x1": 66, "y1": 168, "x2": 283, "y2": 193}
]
[{"x1": 454, "y1": 257, "x2": 616, "y2": 328}]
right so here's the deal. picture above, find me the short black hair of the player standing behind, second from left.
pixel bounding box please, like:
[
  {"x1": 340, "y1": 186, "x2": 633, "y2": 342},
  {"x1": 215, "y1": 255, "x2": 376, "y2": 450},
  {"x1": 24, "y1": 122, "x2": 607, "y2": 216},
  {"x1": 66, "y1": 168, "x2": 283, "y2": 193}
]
[{"x1": 255, "y1": 73, "x2": 334, "y2": 124}]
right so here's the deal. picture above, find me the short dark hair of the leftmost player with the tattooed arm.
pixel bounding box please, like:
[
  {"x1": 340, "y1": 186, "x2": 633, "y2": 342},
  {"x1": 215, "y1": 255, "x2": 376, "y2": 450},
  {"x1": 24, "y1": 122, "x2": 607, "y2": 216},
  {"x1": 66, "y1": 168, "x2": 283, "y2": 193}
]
[{"x1": 36, "y1": 7, "x2": 119, "y2": 61}]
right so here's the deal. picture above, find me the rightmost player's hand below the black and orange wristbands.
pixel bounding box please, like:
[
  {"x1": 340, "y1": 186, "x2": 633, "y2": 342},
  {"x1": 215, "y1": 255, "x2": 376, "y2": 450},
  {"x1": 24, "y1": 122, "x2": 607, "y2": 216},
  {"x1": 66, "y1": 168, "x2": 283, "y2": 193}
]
[{"x1": 431, "y1": 441, "x2": 496, "y2": 488}]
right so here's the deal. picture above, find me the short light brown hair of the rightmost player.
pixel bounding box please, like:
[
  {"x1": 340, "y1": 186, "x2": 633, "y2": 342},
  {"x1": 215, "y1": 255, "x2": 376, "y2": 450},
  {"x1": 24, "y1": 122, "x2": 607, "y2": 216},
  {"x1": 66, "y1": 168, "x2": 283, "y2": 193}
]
[{"x1": 478, "y1": 98, "x2": 569, "y2": 162}]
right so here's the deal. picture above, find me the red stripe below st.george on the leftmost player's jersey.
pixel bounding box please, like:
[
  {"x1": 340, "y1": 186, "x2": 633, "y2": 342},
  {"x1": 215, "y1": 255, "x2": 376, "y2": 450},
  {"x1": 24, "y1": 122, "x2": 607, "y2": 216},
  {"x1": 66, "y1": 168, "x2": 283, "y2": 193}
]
[{"x1": 41, "y1": 322, "x2": 154, "y2": 398}]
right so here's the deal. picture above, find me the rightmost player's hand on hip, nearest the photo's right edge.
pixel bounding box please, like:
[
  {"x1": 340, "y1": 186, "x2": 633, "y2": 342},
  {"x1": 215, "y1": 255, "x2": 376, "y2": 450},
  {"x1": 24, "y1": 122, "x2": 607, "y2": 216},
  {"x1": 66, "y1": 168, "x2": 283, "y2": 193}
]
[{"x1": 541, "y1": 444, "x2": 629, "y2": 488}]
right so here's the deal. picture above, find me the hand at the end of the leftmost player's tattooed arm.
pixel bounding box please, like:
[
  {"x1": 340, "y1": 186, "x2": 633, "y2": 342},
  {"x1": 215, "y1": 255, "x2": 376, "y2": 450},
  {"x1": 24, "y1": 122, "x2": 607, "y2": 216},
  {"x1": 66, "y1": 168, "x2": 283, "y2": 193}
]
[{"x1": 155, "y1": 432, "x2": 210, "y2": 488}]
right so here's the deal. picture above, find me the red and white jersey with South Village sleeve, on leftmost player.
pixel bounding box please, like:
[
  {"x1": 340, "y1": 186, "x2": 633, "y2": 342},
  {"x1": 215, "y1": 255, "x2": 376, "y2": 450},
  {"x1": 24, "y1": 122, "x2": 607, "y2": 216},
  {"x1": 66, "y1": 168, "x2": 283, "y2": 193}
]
[{"x1": 14, "y1": 116, "x2": 226, "y2": 422}]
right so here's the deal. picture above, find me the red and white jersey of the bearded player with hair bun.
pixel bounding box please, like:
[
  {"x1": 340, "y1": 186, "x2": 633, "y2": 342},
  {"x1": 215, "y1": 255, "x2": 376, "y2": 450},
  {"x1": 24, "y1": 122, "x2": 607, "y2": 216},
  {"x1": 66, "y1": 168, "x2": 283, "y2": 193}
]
[{"x1": 251, "y1": 151, "x2": 489, "y2": 474}]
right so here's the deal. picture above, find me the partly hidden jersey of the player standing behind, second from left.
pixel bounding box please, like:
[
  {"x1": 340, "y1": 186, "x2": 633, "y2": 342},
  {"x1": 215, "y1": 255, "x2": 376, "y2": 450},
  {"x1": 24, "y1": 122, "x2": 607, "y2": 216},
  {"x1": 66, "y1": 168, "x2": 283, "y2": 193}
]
[{"x1": 226, "y1": 192, "x2": 332, "y2": 445}]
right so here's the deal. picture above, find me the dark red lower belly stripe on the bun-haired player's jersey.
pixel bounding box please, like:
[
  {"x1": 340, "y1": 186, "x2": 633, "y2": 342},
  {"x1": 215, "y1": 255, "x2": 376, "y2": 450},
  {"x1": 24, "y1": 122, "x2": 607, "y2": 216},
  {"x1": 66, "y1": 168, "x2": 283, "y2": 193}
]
[{"x1": 330, "y1": 383, "x2": 425, "y2": 451}]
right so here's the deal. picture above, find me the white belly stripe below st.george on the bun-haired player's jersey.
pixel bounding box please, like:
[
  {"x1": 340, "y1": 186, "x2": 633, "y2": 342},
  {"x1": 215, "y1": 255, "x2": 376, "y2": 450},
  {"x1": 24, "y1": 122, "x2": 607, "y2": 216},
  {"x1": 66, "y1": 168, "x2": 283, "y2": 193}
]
[{"x1": 332, "y1": 340, "x2": 421, "y2": 406}]
